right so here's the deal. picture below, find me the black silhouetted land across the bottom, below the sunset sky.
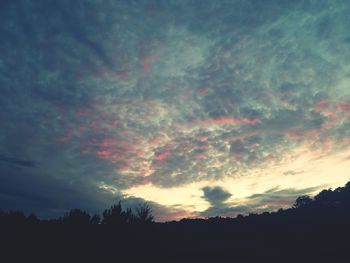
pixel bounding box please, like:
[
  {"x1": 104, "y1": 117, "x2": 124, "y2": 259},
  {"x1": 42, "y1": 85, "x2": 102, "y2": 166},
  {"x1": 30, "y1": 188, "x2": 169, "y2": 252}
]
[{"x1": 0, "y1": 183, "x2": 350, "y2": 263}]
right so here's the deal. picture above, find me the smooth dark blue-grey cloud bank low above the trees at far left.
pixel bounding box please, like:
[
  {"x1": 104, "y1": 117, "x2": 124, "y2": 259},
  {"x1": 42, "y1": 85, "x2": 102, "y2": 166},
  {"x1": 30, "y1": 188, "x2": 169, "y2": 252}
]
[{"x1": 0, "y1": 166, "x2": 103, "y2": 217}]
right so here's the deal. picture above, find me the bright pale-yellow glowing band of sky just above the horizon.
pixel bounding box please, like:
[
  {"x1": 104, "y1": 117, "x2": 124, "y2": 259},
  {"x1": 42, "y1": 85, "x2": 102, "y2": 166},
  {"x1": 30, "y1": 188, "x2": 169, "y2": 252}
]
[{"x1": 117, "y1": 145, "x2": 350, "y2": 222}]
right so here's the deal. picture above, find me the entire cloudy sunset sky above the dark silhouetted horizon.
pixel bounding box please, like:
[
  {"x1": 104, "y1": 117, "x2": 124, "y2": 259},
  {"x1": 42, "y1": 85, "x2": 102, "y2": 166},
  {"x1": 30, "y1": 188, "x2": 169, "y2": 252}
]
[{"x1": 0, "y1": 0, "x2": 350, "y2": 221}]
